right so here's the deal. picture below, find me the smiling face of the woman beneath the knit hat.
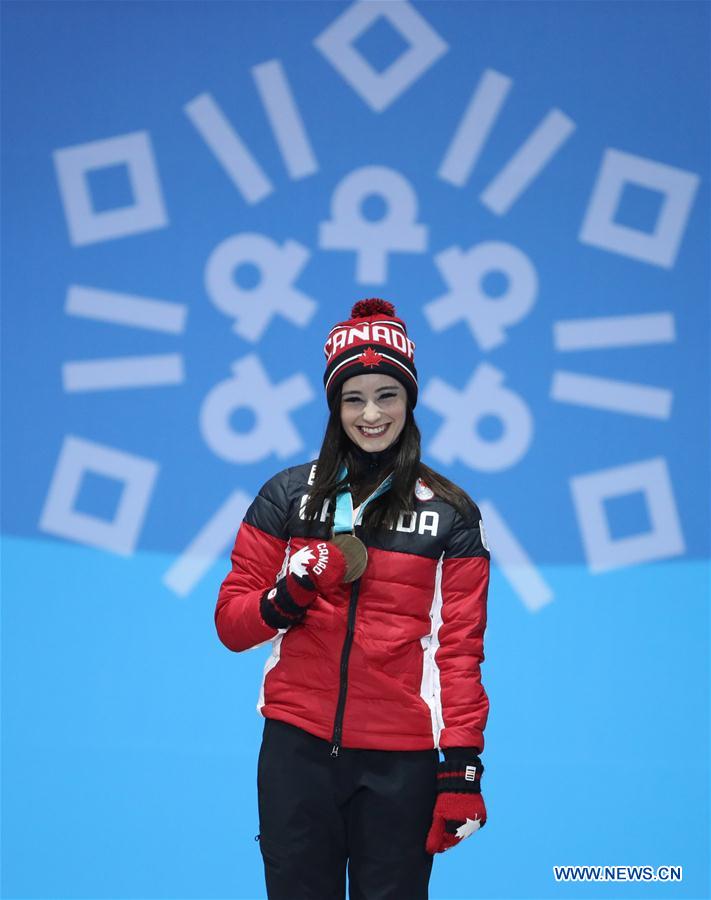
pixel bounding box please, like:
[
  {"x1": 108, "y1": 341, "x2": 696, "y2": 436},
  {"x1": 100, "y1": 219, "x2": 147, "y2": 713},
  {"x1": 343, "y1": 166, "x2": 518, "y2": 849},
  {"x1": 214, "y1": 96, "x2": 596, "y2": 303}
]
[{"x1": 341, "y1": 374, "x2": 407, "y2": 452}]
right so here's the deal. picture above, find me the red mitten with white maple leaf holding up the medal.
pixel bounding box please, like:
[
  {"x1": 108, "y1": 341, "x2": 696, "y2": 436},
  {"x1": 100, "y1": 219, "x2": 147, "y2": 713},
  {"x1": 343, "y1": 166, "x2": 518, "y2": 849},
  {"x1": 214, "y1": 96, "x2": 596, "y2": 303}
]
[{"x1": 260, "y1": 541, "x2": 346, "y2": 628}]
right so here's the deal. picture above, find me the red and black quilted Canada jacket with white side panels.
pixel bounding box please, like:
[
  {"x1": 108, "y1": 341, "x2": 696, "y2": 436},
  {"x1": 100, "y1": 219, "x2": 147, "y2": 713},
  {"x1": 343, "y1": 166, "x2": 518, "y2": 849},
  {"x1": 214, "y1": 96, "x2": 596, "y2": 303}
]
[{"x1": 215, "y1": 462, "x2": 489, "y2": 750}]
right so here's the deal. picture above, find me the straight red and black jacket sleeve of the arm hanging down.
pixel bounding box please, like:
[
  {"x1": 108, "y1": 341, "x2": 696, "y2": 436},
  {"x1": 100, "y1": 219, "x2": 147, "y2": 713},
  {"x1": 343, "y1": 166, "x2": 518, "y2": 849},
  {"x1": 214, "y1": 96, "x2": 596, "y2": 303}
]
[{"x1": 435, "y1": 506, "x2": 490, "y2": 752}]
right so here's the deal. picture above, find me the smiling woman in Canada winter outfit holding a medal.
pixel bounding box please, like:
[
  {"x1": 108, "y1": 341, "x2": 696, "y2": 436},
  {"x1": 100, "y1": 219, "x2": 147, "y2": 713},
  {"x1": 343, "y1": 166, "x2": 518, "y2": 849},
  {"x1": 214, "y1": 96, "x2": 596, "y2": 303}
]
[{"x1": 215, "y1": 299, "x2": 489, "y2": 900}]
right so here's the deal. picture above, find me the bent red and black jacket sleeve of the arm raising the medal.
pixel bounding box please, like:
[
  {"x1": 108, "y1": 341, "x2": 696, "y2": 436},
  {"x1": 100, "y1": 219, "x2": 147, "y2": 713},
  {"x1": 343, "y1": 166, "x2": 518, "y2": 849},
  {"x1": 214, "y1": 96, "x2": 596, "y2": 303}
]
[{"x1": 215, "y1": 469, "x2": 289, "y2": 651}]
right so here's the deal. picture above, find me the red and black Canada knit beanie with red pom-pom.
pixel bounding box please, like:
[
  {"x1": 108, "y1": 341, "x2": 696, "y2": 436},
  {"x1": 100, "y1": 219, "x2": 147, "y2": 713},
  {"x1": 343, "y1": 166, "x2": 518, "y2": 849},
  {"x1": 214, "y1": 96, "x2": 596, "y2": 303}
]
[{"x1": 323, "y1": 297, "x2": 417, "y2": 409}]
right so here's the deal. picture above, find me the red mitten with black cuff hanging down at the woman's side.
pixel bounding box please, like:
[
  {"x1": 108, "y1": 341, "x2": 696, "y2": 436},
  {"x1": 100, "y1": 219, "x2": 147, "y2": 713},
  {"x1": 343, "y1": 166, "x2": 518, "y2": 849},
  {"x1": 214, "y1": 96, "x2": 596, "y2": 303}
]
[{"x1": 425, "y1": 757, "x2": 486, "y2": 855}]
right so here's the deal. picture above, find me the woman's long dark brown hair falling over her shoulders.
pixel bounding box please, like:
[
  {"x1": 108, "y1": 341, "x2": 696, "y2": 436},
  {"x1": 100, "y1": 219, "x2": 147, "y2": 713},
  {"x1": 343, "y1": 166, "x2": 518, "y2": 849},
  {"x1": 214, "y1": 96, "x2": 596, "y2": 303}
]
[{"x1": 304, "y1": 387, "x2": 475, "y2": 529}]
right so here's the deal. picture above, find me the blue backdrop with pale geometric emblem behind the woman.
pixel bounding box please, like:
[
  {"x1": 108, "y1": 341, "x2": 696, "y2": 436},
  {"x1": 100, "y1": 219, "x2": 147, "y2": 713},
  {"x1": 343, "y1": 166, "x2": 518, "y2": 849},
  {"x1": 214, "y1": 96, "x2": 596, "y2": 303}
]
[{"x1": 2, "y1": 0, "x2": 711, "y2": 900}]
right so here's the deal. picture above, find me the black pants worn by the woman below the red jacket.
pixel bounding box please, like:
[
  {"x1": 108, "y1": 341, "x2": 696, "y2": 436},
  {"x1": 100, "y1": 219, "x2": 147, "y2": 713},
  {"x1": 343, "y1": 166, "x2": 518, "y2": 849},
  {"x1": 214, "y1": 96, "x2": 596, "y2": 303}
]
[{"x1": 257, "y1": 719, "x2": 439, "y2": 900}]
